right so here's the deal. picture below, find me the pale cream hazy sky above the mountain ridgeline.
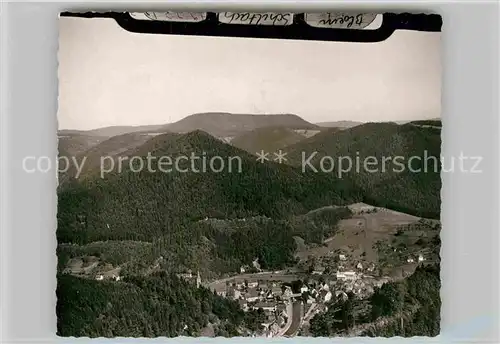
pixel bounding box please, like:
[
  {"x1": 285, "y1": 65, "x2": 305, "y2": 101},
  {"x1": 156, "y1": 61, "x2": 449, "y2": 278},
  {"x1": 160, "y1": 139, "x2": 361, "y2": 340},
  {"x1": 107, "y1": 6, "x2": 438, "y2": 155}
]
[{"x1": 58, "y1": 17, "x2": 441, "y2": 129}]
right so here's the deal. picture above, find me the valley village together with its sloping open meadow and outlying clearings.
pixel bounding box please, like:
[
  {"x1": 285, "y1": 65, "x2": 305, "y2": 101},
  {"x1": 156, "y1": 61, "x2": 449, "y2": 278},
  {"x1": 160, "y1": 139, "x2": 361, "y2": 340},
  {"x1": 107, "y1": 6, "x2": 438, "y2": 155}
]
[{"x1": 63, "y1": 203, "x2": 440, "y2": 337}]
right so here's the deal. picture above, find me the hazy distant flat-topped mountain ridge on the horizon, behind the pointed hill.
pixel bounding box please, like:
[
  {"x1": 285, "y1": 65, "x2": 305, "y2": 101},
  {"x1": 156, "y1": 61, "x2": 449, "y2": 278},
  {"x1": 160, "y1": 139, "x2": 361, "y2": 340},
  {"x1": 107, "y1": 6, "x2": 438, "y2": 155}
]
[{"x1": 58, "y1": 112, "x2": 321, "y2": 156}]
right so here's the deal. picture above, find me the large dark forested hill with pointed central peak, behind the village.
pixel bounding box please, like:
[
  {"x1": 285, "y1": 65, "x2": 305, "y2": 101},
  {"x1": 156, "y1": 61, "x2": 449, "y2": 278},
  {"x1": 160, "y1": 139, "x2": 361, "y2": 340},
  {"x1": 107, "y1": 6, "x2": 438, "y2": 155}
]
[{"x1": 57, "y1": 131, "x2": 361, "y2": 243}]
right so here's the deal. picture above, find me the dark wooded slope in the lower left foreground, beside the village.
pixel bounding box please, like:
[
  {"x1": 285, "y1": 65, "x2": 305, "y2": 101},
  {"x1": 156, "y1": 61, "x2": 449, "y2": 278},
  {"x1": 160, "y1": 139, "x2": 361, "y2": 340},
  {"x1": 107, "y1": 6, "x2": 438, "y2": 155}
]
[{"x1": 56, "y1": 272, "x2": 268, "y2": 338}]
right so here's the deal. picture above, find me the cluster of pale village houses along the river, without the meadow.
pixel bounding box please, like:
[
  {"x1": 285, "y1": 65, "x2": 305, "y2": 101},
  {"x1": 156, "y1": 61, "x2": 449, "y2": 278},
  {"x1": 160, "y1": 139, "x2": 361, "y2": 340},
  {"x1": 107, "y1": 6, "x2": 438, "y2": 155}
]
[{"x1": 178, "y1": 254, "x2": 432, "y2": 337}]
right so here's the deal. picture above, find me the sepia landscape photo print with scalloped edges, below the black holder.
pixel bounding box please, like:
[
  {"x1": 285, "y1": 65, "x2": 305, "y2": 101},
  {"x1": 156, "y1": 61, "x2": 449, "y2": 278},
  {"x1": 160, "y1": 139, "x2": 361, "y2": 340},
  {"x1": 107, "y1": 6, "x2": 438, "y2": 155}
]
[{"x1": 55, "y1": 14, "x2": 442, "y2": 338}]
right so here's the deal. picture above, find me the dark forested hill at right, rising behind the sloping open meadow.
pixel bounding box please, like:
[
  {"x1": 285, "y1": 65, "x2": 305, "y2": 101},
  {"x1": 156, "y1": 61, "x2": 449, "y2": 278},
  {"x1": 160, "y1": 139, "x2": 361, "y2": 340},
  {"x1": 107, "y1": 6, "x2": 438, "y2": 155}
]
[{"x1": 287, "y1": 123, "x2": 441, "y2": 218}]
